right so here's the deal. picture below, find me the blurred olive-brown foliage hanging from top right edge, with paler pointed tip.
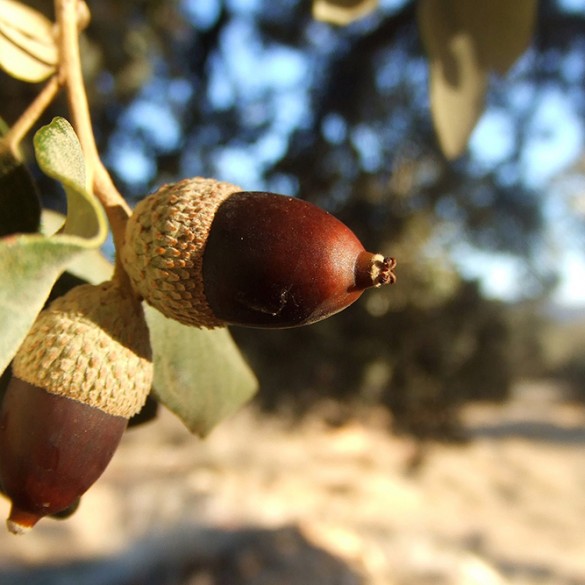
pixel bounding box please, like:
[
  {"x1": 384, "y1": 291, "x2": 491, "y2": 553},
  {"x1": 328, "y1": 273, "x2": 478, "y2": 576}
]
[{"x1": 418, "y1": 0, "x2": 536, "y2": 159}]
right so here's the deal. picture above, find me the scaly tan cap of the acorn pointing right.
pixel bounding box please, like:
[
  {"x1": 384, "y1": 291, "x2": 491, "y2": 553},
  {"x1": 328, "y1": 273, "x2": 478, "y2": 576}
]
[{"x1": 121, "y1": 177, "x2": 242, "y2": 328}]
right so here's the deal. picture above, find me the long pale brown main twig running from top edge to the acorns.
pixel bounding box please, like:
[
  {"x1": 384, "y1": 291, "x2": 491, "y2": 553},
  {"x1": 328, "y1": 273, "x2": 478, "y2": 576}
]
[{"x1": 55, "y1": 0, "x2": 131, "y2": 273}]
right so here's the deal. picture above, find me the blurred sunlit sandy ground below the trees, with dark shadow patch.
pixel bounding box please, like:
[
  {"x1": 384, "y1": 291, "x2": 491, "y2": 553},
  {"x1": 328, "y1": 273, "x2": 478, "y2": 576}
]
[{"x1": 0, "y1": 384, "x2": 585, "y2": 585}]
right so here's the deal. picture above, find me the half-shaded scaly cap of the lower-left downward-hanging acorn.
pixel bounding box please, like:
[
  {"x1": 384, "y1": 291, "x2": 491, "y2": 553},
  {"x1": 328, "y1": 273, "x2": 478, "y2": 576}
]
[{"x1": 12, "y1": 281, "x2": 153, "y2": 418}]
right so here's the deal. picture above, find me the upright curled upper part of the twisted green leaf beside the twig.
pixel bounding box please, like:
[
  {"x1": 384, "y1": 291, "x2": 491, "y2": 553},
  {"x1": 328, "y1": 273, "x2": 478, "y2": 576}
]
[{"x1": 34, "y1": 118, "x2": 107, "y2": 243}]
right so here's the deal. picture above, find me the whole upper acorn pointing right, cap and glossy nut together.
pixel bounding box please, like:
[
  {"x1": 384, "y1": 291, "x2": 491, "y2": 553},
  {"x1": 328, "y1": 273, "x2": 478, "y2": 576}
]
[{"x1": 121, "y1": 177, "x2": 396, "y2": 328}]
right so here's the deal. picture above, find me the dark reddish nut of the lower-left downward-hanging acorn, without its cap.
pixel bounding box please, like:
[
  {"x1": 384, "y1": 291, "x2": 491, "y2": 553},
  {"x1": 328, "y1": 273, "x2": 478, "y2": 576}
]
[{"x1": 0, "y1": 377, "x2": 128, "y2": 533}]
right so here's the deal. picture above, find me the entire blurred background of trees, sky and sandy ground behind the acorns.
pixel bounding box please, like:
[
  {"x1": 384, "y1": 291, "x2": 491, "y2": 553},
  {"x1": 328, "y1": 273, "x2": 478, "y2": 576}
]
[{"x1": 0, "y1": 0, "x2": 585, "y2": 585}]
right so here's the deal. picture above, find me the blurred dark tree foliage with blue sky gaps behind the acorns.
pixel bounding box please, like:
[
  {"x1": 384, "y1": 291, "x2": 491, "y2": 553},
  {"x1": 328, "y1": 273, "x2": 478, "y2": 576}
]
[{"x1": 0, "y1": 0, "x2": 585, "y2": 437}]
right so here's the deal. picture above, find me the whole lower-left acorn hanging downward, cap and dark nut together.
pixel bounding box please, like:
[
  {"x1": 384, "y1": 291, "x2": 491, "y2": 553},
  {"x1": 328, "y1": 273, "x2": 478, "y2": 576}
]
[{"x1": 0, "y1": 281, "x2": 152, "y2": 533}]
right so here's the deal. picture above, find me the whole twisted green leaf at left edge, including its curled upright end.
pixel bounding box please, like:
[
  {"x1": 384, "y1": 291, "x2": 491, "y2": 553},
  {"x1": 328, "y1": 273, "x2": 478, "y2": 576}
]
[{"x1": 0, "y1": 119, "x2": 107, "y2": 372}]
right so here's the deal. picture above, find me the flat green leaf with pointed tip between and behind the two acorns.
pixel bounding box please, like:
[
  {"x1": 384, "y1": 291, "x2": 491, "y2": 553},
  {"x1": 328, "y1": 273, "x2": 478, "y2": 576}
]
[{"x1": 145, "y1": 307, "x2": 258, "y2": 436}]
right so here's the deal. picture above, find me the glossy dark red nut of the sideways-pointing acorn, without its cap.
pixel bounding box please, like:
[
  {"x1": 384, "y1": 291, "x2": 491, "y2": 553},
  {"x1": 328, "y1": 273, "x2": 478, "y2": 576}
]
[{"x1": 203, "y1": 192, "x2": 394, "y2": 327}]
